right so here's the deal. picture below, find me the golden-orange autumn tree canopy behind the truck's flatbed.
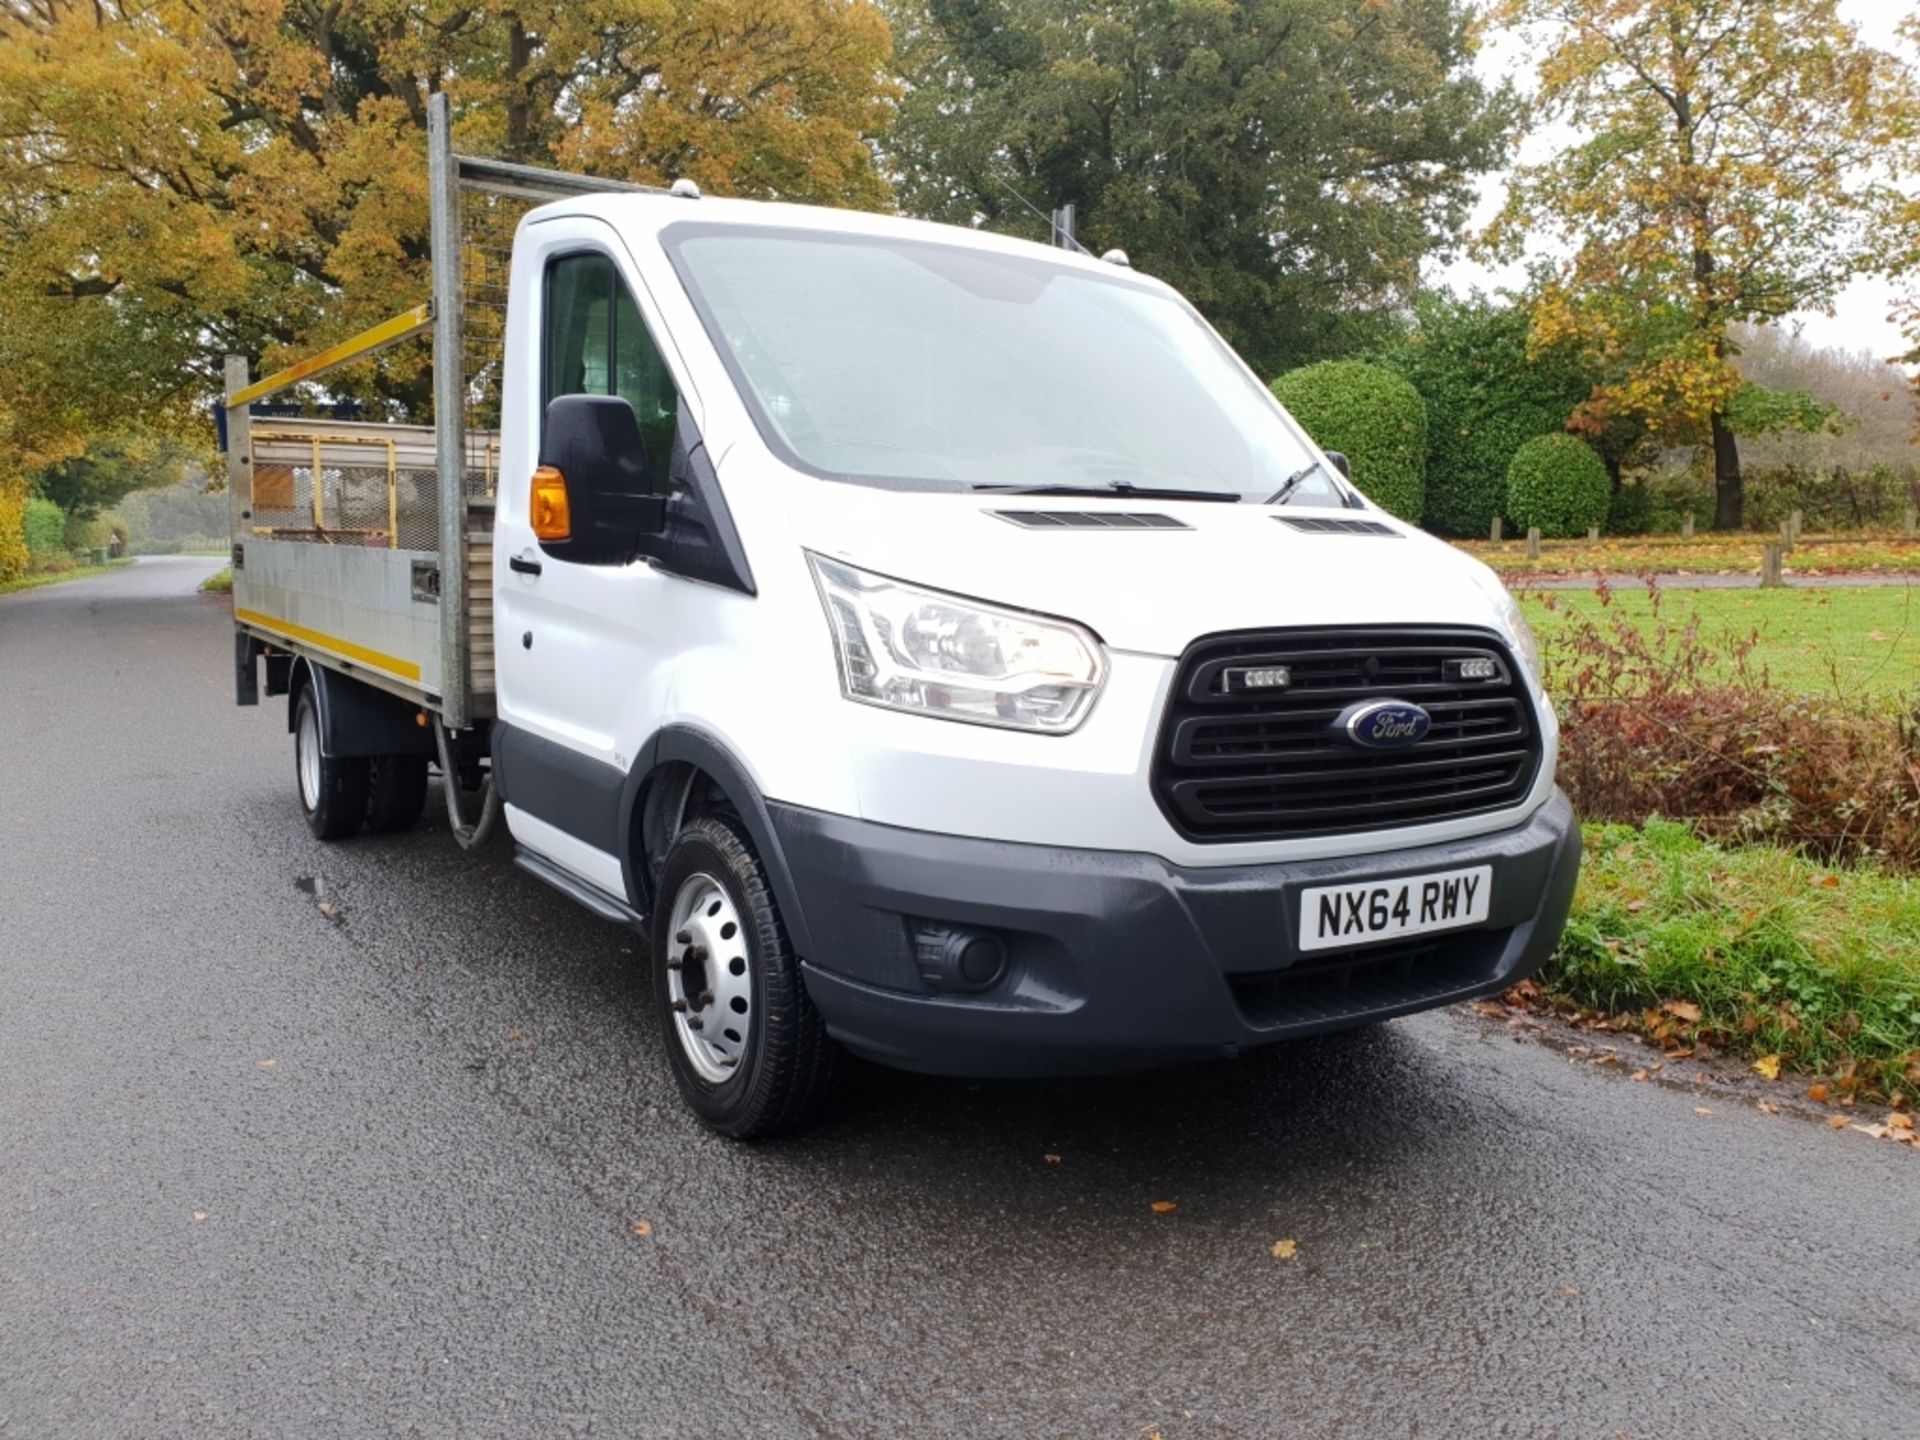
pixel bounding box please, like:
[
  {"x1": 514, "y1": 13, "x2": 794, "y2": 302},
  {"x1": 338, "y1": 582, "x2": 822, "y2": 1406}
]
[{"x1": 0, "y1": 0, "x2": 895, "y2": 468}]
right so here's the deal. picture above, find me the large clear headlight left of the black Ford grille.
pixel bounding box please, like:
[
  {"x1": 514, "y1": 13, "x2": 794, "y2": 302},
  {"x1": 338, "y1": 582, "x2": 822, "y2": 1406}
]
[{"x1": 806, "y1": 555, "x2": 1106, "y2": 733}]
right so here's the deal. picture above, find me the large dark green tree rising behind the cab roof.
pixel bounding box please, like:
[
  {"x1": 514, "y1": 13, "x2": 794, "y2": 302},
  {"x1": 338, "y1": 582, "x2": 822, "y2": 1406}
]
[{"x1": 885, "y1": 0, "x2": 1513, "y2": 374}]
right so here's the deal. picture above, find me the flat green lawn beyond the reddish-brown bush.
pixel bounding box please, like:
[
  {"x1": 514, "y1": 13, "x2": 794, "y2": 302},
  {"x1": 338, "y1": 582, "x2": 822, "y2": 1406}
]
[{"x1": 1521, "y1": 584, "x2": 1920, "y2": 697}]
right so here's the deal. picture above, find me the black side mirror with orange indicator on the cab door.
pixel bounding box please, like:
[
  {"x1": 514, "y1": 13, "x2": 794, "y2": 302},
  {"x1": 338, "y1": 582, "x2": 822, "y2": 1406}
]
[{"x1": 532, "y1": 396, "x2": 666, "y2": 564}]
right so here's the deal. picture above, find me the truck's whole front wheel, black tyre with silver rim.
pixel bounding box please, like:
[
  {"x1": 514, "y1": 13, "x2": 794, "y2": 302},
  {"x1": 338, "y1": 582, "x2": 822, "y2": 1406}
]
[{"x1": 653, "y1": 814, "x2": 839, "y2": 1140}]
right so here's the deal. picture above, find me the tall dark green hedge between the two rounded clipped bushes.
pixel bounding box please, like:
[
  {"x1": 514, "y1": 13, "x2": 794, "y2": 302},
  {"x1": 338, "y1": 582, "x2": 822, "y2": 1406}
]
[{"x1": 1375, "y1": 292, "x2": 1592, "y2": 536}]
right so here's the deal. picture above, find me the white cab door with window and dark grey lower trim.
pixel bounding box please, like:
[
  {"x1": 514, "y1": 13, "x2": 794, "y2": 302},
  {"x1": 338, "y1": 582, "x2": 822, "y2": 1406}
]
[{"x1": 493, "y1": 217, "x2": 691, "y2": 895}]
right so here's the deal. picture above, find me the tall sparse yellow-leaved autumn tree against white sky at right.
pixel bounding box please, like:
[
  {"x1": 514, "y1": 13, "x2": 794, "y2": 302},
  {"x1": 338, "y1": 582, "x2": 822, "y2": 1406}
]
[{"x1": 1490, "y1": 0, "x2": 1920, "y2": 530}]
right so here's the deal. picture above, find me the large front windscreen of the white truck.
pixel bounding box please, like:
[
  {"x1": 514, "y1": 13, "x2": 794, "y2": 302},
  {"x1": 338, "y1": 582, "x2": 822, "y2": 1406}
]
[{"x1": 666, "y1": 225, "x2": 1340, "y2": 505}]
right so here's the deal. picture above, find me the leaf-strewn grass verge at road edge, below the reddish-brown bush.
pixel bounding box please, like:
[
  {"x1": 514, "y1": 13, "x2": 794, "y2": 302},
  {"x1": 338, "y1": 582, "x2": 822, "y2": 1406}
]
[{"x1": 1538, "y1": 820, "x2": 1920, "y2": 1106}]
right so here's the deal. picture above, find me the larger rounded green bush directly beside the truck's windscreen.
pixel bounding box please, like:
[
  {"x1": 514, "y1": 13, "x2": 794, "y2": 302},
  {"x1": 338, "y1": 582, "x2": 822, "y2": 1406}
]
[{"x1": 1273, "y1": 361, "x2": 1427, "y2": 524}]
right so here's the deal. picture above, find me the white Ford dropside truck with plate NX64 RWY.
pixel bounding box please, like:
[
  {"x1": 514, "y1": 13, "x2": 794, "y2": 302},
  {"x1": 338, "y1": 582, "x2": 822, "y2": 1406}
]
[{"x1": 225, "y1": 100, "x2": 1580, "y2": 1137}]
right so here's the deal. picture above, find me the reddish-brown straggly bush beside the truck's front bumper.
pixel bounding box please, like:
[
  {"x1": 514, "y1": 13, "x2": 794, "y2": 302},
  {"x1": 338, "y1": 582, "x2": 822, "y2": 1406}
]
[{"x1": 1544, "y1": 586, "x2": 1920, "y2": 874}]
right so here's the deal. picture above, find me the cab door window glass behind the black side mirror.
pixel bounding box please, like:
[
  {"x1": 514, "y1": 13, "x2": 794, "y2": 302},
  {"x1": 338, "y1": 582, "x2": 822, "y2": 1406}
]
[{"x1": 540, "y1": 252, "x2": 678, "y2": 492}]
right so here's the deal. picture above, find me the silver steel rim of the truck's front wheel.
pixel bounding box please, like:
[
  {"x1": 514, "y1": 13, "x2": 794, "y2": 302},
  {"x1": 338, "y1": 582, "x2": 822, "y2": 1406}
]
[{"x1": 666, "y1": 872, "x2": 753, "y2": 1085}]
